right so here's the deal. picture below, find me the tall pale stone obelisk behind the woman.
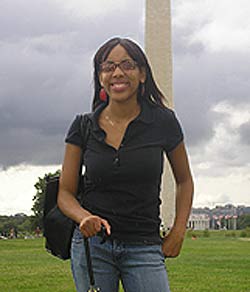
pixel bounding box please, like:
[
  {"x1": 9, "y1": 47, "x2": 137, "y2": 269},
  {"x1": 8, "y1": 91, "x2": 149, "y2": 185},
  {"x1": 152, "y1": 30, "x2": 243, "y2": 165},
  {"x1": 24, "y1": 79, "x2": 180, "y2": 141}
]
[{"x1": 145, "y1": 0, "x2": 175, "y2": 227}]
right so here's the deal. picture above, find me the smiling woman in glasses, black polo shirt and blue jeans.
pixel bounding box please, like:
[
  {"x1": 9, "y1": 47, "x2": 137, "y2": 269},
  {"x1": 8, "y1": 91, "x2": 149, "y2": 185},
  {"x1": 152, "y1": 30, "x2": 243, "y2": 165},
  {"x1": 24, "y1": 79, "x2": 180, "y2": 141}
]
[{"x1": 58, "y1": 38, "x2": 193, "y2": 292}]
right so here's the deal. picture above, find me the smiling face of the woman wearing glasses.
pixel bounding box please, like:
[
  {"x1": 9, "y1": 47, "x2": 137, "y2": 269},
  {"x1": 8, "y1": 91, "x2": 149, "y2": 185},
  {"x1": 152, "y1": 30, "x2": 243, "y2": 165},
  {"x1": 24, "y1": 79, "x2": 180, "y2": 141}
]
[{"x1": 99, "y1": 45, "x2": 146, "y2": 102}]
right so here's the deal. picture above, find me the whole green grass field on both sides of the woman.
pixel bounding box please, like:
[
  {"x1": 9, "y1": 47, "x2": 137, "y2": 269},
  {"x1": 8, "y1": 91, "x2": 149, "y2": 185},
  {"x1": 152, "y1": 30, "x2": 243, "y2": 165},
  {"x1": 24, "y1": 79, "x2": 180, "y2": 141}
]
[{"x1": 0, "y1": 232, "x2": 250, "y2": 292}]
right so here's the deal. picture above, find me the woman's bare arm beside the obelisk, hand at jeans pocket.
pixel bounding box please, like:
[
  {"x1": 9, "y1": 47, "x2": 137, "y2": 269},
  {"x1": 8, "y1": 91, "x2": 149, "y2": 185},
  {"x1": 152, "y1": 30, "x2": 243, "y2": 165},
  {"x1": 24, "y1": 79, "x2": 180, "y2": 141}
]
[{"x1": 162, "y1": 142, "x2": 194, "y2": 257}]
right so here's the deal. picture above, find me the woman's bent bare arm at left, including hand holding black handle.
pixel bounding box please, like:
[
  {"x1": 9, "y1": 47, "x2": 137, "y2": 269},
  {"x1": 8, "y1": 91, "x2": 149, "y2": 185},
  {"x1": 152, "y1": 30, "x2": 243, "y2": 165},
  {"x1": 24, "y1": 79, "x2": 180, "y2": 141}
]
[{"x1": 57, "y1": 144, "x2": 110, "y2": 237}]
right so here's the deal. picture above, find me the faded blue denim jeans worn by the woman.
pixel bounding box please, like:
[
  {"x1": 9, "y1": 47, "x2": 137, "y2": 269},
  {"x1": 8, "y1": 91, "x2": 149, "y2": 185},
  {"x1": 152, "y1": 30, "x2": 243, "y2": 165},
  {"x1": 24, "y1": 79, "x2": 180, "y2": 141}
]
[{"x1": 71, "y1": 228, "x2": 170, "y2": 292}]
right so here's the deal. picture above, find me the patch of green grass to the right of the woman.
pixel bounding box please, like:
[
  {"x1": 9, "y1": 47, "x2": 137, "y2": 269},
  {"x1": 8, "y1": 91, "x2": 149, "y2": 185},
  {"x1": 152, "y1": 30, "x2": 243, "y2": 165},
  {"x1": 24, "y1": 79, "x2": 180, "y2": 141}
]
[{"x1": 166, "y1": 237, "x2": 250, "y2": 292}]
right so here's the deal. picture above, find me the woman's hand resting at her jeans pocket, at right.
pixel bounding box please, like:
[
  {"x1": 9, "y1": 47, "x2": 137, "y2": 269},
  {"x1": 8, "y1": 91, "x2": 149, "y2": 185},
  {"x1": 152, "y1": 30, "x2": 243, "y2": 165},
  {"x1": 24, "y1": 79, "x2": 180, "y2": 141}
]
[{"x1": 162, "y1": 228, "x2": 185, "y2": 257}]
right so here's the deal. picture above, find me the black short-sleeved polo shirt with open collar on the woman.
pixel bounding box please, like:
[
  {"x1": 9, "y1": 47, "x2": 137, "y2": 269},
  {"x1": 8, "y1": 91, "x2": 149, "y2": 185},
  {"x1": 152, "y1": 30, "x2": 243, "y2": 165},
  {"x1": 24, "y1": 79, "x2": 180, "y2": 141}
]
[{"x1": 65, "y1": 101, "x2": 183, "y2": 243}]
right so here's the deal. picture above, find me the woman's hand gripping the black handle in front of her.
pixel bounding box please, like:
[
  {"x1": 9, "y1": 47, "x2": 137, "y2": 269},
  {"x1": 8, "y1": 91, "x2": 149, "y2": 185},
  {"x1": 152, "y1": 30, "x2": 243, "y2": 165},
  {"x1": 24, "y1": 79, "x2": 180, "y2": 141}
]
[{"x1": 79, "y1": 215, "x2": 111, "y2": 237}]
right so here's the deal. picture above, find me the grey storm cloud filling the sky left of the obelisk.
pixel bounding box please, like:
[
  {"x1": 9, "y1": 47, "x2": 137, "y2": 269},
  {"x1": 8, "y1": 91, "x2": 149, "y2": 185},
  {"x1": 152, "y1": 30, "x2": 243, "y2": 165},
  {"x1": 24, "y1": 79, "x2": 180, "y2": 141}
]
[{"x1": 0, "y1": 0, "x2": 143, "y2": 168}]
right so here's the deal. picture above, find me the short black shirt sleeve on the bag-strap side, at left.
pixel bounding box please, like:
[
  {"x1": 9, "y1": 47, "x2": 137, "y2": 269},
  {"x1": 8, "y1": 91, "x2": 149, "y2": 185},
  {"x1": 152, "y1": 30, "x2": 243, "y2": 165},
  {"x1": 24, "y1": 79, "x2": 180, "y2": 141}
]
[{"x1": 65, "y1": 115, "x2": 83, "y2": 148}]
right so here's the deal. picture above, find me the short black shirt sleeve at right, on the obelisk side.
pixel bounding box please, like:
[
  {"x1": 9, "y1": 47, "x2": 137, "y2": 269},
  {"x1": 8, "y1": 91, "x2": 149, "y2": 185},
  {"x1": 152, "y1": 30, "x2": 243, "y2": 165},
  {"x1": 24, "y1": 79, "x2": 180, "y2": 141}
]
[{"x1": 164, "y1": 110, "x2": 184, "y2": 153}]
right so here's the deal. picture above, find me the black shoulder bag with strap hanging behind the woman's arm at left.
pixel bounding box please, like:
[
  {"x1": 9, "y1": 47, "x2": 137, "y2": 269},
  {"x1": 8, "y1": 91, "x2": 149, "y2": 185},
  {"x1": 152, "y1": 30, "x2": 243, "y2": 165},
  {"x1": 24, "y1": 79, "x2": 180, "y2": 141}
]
[{"x1": 43, "y1": 115, "x2": 90, "y2": 260}]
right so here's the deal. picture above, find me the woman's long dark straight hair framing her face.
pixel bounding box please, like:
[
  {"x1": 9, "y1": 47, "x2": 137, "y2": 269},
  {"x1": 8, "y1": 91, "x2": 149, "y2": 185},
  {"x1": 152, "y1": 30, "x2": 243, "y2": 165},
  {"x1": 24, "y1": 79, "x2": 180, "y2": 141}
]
[{"x1": 92, "y1": 37, "x2": 166, "y2": 110}]
